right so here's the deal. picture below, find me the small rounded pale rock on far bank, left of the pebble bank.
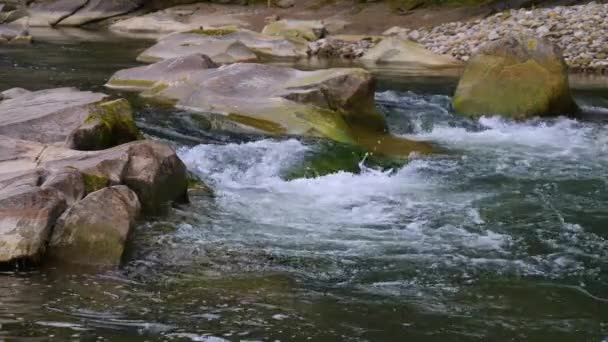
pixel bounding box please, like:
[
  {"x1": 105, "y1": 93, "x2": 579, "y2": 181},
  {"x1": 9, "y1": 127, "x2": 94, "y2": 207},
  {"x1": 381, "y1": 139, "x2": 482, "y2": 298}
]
[{"x1": 262, "y1": 19, "x2": 327, "y2": 42}]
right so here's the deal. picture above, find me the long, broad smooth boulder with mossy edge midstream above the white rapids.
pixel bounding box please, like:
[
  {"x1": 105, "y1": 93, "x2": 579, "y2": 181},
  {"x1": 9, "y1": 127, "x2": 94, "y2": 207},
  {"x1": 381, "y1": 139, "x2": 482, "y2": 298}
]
[{"x1": 106, "y1": 56, "x2": 430, "y2": 155}]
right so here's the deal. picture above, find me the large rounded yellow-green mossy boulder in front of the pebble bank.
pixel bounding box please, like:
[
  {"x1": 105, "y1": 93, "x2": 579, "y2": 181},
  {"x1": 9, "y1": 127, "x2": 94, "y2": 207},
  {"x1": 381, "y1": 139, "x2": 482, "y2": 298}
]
[{"x1": 453, "y1": 36, "x2": 578, "y2": 119}]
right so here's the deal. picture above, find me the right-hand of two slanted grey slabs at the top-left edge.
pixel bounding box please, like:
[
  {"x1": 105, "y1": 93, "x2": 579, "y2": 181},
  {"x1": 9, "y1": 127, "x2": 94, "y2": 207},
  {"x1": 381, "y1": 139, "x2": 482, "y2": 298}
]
[{"x1": 57, "y1": 0, "x2": 144, "y2": 26}]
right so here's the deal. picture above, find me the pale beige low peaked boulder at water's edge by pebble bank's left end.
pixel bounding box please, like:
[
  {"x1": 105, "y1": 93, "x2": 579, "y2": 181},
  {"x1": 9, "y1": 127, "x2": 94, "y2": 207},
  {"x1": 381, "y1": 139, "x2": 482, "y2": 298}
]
[{"x1": 361, "y1": 37, "x2": 462, "y2": 71}]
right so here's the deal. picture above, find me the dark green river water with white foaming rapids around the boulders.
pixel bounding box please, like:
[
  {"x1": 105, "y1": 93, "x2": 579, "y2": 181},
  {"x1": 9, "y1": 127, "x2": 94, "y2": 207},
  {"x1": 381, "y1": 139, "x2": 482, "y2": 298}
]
[{"x1": 0, "y1": 30, "x2": 608, "y2": 342}]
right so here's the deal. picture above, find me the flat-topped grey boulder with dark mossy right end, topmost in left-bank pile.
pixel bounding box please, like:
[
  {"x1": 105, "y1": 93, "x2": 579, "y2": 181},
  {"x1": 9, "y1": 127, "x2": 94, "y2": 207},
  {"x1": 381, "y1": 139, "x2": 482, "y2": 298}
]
[{"x1": 0, "y1": 88, "x2": 140, "y2": 150}]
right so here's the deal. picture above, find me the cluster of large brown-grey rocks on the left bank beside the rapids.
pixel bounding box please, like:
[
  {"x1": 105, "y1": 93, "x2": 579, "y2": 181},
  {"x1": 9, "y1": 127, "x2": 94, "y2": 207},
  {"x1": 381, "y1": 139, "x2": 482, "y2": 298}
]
[{"x1": 0, "y1": 88, "x2": 187, "y2": 266}]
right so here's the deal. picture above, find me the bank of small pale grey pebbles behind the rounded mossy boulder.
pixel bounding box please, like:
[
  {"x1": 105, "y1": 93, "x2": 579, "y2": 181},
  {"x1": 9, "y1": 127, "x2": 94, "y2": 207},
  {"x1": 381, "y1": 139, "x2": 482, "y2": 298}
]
[{"x1": 385, "y1": 2, "x2": 608, "y2": 71}]
